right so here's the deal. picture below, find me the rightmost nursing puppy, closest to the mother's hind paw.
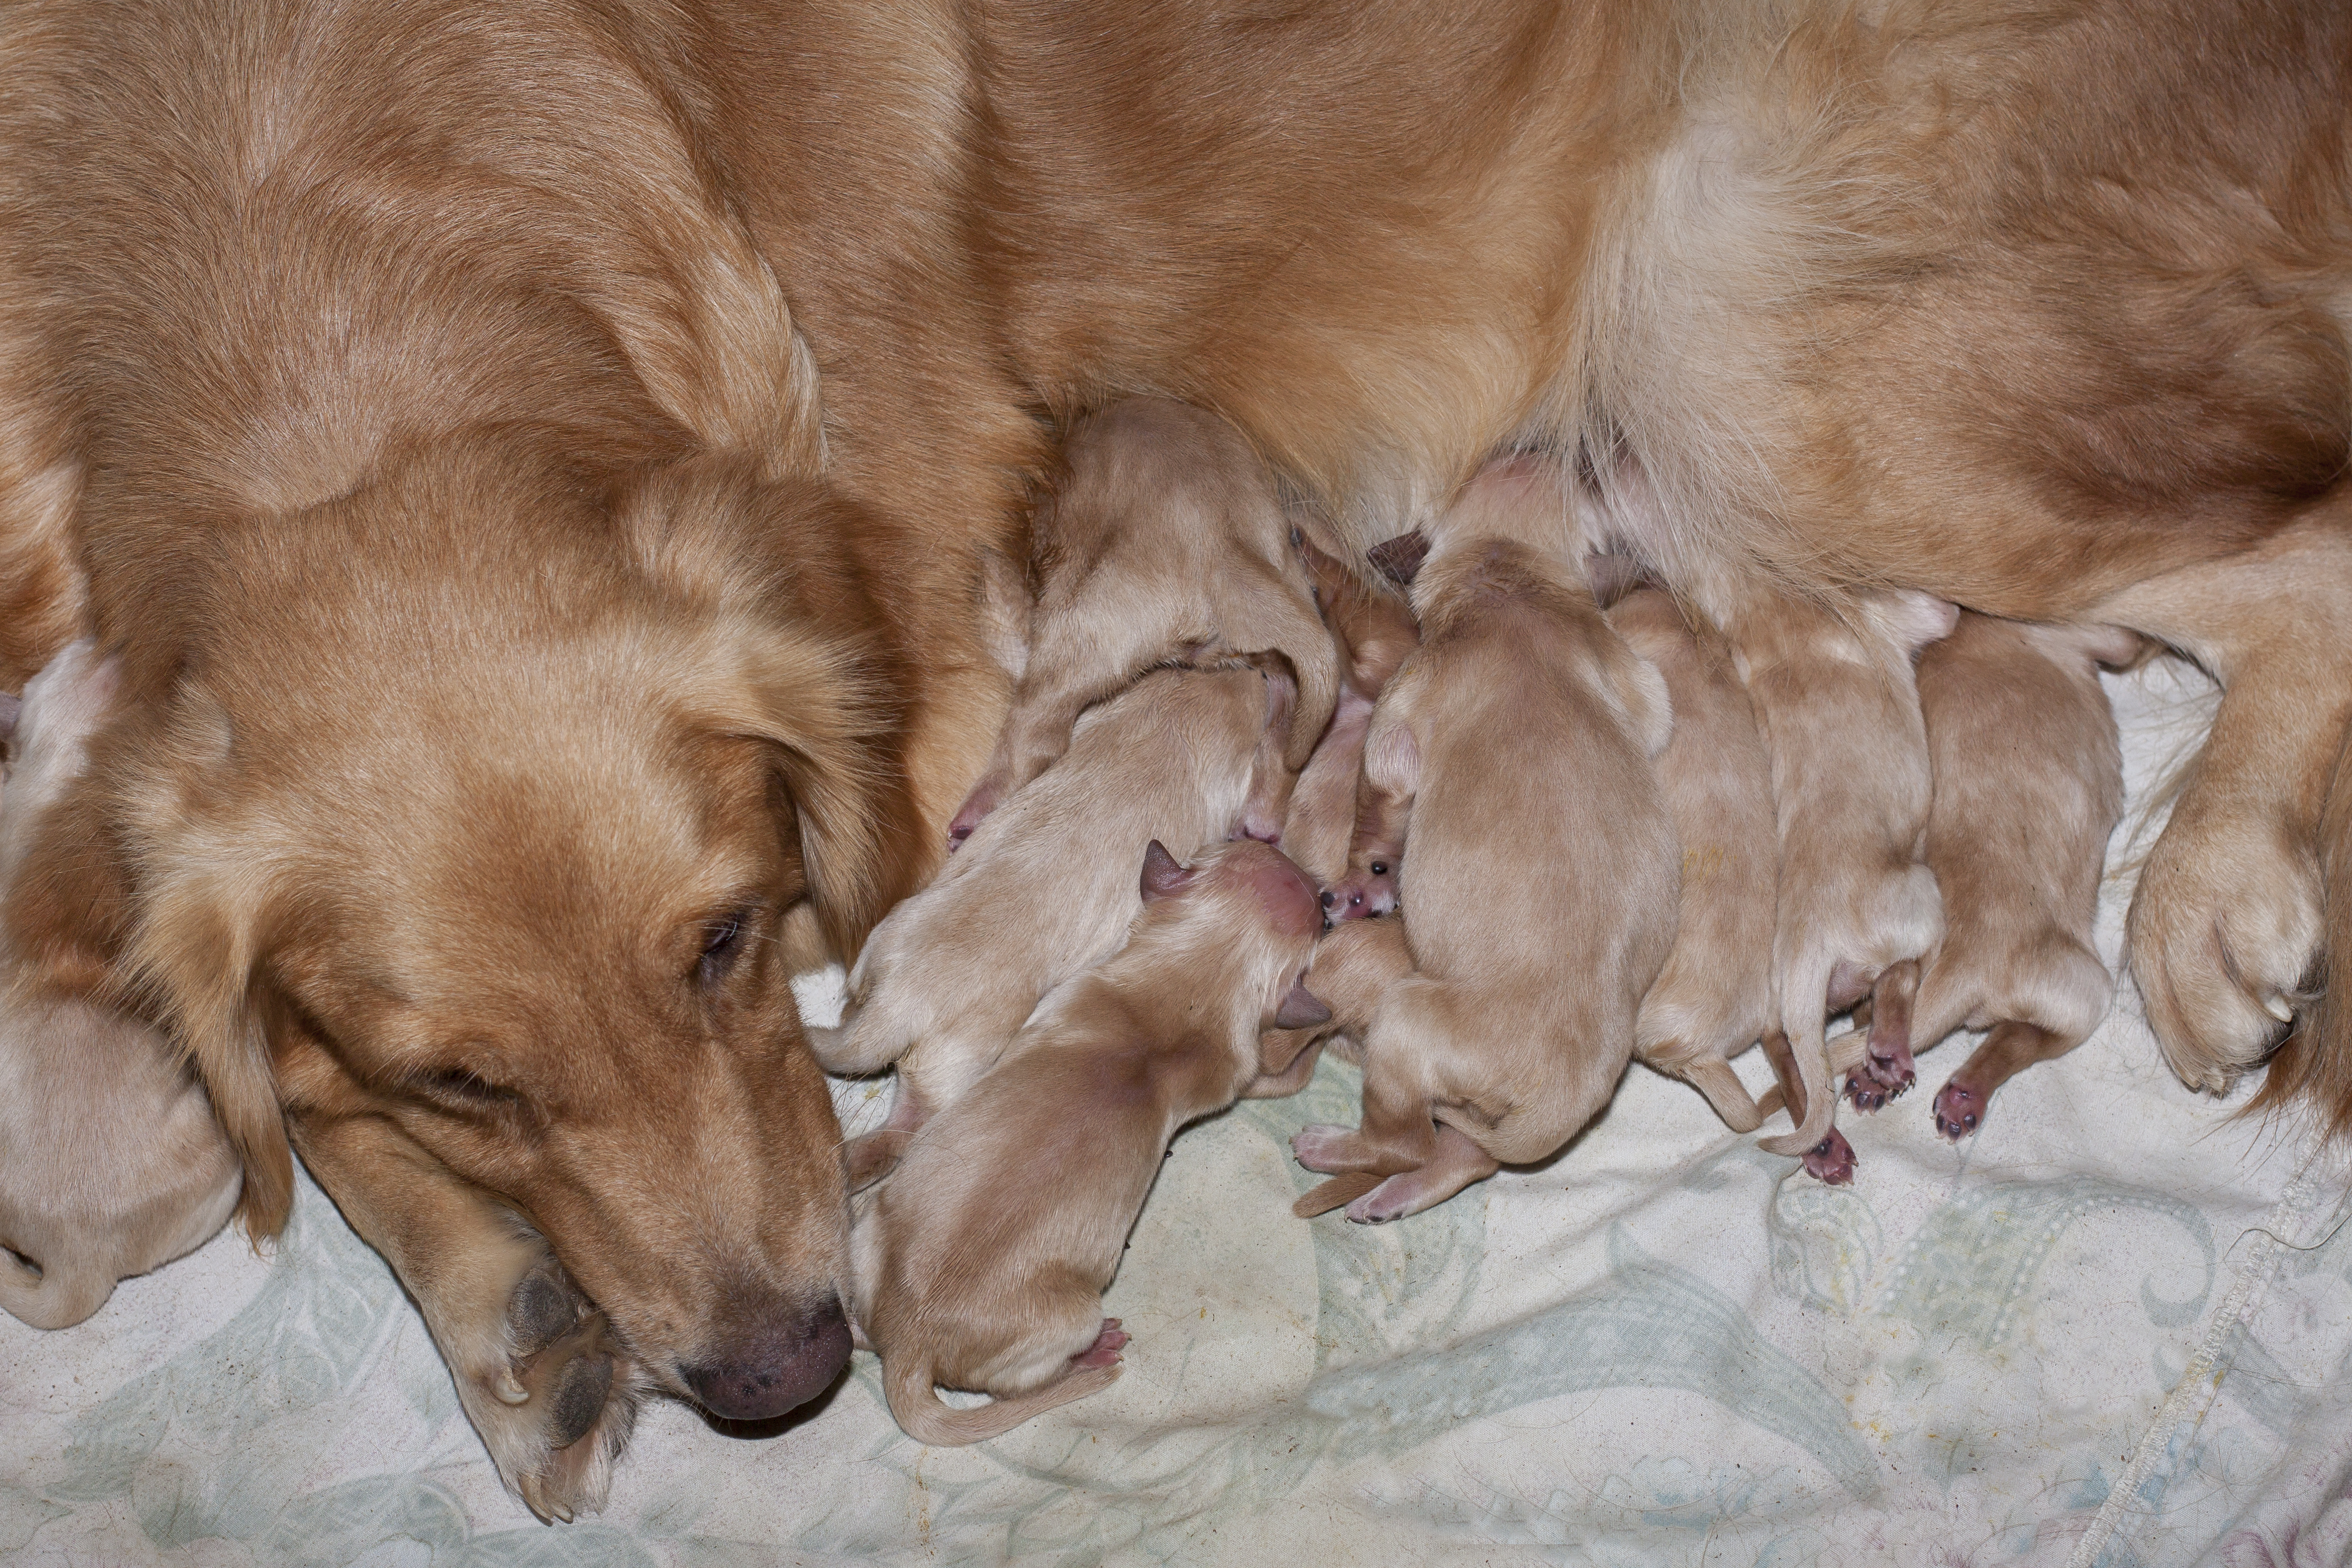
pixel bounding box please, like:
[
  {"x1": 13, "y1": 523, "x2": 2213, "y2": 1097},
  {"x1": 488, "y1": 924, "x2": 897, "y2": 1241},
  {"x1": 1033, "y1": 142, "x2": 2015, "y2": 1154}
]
[{"x1": 1837, "y1": 614, "x2": 2143, "y2": 1140}]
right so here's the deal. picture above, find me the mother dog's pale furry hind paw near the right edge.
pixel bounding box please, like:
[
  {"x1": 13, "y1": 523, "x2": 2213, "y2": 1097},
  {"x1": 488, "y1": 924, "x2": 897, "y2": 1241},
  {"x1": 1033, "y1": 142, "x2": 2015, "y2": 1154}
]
[{"x1": 2131, "y1": 808, "x2": 2321, "y2": 1093}]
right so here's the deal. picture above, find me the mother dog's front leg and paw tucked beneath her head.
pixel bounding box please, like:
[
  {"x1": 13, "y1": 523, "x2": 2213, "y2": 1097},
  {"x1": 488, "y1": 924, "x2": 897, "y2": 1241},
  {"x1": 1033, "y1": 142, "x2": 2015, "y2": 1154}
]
[{"x1": 292, "y1": 1114, "x2": 644, "y2": 1521}]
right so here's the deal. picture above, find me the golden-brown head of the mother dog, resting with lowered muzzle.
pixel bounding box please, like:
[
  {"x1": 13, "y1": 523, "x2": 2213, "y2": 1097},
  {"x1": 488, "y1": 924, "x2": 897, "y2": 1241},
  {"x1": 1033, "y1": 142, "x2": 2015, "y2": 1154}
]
[{"x1": 9, "y1": 454, "x2": 920, "y2": 1418}]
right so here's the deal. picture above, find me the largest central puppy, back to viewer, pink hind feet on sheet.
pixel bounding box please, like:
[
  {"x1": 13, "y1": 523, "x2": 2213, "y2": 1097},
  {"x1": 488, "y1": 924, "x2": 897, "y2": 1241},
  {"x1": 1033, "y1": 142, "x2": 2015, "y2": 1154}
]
[{"x1": 1291, "y1": 458, "x2": 1679, "y2": 1220}]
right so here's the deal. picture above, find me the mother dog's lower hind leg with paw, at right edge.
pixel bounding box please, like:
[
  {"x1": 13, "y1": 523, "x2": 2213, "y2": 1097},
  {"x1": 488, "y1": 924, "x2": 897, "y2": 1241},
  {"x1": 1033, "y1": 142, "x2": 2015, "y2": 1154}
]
[{"x1": 2084, "y1": 505, "x2": 2352, "y2": 1105}]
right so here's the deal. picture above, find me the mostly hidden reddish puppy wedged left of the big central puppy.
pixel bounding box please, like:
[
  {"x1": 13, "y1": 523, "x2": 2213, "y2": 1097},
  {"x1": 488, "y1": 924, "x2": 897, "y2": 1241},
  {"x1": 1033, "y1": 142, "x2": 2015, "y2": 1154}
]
[{"x1": 1282, "y1": 536, "x2": 1421, "y2": 886}]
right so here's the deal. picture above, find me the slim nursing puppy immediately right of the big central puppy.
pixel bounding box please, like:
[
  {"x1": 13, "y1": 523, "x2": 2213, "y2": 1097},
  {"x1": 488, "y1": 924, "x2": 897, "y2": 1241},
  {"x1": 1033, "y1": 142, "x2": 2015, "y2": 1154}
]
[{"x1": 1609, "y1": 588, "x2": 1780, "y2": 1133}]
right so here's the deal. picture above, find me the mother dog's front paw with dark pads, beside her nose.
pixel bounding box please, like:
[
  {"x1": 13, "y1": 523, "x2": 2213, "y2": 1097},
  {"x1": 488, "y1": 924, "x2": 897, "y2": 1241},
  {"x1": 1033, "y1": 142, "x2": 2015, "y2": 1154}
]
[{"x1": 435, "y1": 1241, "x2": 647, "y2": 1521}]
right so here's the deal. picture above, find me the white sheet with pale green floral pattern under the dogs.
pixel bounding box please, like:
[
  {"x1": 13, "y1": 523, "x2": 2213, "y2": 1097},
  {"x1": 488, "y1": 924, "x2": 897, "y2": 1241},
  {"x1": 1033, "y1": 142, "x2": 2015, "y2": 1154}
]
[{"x1": 0, "y1": 668, "x2": 2352, "y2": 1568}]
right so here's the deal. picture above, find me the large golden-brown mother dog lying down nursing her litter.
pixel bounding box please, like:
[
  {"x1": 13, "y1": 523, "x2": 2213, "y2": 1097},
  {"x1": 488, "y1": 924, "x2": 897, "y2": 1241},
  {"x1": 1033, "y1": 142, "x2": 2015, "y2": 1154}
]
[{"x1": 0, "y1": 0, "x2": 2352, "y2": 1517}]
